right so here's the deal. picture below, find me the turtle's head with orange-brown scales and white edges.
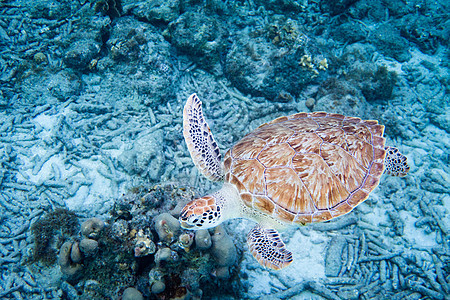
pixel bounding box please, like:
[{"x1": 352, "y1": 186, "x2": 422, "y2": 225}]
[{"x1": 180, "y1": 195, "x2": 223, "y2": 230}]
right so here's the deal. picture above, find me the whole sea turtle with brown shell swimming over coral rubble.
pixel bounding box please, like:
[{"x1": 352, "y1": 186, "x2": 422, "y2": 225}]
[{"x1": 179, "y1": 94, "x2": 409, "y2": 270}]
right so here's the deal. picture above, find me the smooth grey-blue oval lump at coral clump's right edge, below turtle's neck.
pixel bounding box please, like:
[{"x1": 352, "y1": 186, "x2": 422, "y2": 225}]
[{"x1": 211, "y1": 225, "x2": 237, "y2": 267}]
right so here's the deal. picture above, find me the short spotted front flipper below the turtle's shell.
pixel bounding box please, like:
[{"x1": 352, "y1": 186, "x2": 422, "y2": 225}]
[{"x1": 247, "y1": 225, "x2": 292, "y2": 270}]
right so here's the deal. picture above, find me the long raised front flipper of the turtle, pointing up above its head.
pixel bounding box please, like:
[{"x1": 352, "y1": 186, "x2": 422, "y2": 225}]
[{"x1": 183, "y1": 94, "x2": 223, "y2": 181}]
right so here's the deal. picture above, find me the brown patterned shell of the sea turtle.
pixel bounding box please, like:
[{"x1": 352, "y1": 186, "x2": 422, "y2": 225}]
[{"x1": 224, "y1": 112, "x2": 385, "y2": 224}]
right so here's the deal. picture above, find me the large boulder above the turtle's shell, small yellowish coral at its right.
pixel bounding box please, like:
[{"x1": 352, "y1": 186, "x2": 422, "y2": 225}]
[{"x1": 225, "y1": 21, "x2": 319, "y2": 100}]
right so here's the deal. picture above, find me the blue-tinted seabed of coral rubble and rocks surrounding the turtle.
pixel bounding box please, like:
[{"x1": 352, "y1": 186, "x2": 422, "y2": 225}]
[{"x1": 0, "y1": 0, "x2": 450, "y2": 300}]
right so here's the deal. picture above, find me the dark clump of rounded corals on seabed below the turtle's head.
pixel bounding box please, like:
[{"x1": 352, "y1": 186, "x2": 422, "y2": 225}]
[{"x1": 29, "y1": 185, "x2": 239, "y2": 299}]
